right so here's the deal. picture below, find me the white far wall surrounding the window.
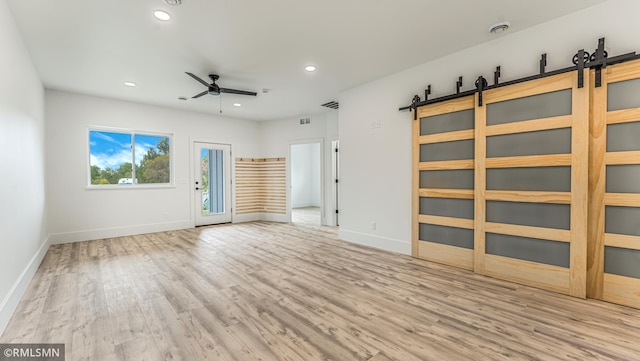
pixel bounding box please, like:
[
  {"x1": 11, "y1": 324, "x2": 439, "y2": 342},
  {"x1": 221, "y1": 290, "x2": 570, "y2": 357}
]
[{"x1": 46, "y1": 90, "x2": 259, "y2": 243}]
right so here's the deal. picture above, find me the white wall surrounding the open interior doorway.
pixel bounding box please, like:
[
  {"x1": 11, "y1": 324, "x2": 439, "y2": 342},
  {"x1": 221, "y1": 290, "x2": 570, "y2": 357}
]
[{"x1": 259, "y1": 110, "x2": 338, "y2": 225}]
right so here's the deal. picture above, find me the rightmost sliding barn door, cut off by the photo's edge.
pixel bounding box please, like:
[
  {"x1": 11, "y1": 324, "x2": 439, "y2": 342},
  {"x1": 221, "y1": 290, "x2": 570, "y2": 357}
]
[{"x1": 588, "y1": 61, "x2": 640, "y2": 308}]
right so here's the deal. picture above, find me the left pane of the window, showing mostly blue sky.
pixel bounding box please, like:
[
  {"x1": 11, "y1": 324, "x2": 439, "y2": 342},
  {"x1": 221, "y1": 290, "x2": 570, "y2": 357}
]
[{"x1": 89, "y1": 130, "x2": 133, "y2": 185}]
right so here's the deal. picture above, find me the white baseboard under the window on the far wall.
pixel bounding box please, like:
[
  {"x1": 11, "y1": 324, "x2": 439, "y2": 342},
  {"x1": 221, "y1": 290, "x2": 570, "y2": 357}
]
[{"x1": 49, "y1": 220, "x2": 193, "y2": 244}]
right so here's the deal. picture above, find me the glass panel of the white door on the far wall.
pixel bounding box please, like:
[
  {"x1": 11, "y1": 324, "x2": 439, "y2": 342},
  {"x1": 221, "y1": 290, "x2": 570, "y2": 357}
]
[{"x1": 200, "y1": 149, "x2": 225, "y2": 215}]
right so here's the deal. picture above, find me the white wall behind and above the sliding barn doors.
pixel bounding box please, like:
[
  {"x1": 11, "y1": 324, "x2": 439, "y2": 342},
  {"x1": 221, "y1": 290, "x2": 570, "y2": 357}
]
[{"x1": 339, "y1": 0, "x2": 640, "y2": 254}]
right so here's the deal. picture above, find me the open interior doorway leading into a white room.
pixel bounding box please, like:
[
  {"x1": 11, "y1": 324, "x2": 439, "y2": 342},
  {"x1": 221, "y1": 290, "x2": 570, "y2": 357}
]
[{"x1": 289, "y1": 141, "x2": 323, "y2": 226}]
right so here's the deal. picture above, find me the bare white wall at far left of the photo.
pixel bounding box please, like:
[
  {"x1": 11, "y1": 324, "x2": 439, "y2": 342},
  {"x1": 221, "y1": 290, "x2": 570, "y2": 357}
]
[{"x1": 0, "y1": 0, "x2": 48, "y2": 334}]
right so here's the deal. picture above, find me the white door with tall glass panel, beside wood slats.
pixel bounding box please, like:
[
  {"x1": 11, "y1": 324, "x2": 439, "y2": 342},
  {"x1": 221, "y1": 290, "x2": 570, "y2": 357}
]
[{"x1": 193, "y1": 142, "x2": 231, "y2": 226}]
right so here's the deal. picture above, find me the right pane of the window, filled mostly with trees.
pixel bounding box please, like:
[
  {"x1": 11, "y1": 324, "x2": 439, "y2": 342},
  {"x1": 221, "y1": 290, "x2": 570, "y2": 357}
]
[{"x1": 134, "y1": 134, "x2": 171, "y2": 184}]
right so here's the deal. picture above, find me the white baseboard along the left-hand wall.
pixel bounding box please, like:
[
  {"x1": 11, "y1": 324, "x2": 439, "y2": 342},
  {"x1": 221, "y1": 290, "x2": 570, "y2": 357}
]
[{"x1": 0, "y1": 233, "x2": 51, "y2": 335}]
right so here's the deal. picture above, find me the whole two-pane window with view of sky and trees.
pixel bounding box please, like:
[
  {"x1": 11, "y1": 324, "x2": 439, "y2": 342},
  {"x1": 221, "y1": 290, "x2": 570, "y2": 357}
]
[{"x1": 89, "y1": 129, "x2": 171, "y2": 186}]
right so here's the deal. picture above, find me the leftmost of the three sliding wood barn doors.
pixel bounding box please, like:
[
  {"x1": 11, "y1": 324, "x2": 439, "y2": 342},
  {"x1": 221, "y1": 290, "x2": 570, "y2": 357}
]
[{"x1": 412, "y1": 96, "x2": 475, "y2": 270}]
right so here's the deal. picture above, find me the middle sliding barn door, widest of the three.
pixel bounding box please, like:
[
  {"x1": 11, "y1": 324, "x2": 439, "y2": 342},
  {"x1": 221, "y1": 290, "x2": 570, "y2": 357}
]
[{"x1": 474, "y1": 72, "x2": 589, "y2": 297}]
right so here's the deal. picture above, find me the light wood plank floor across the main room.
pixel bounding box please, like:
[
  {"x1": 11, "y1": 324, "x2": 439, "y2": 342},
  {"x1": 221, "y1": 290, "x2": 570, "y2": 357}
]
[{"x1": 0, "y1": 222, "x2": 640, "y2": 361}]
